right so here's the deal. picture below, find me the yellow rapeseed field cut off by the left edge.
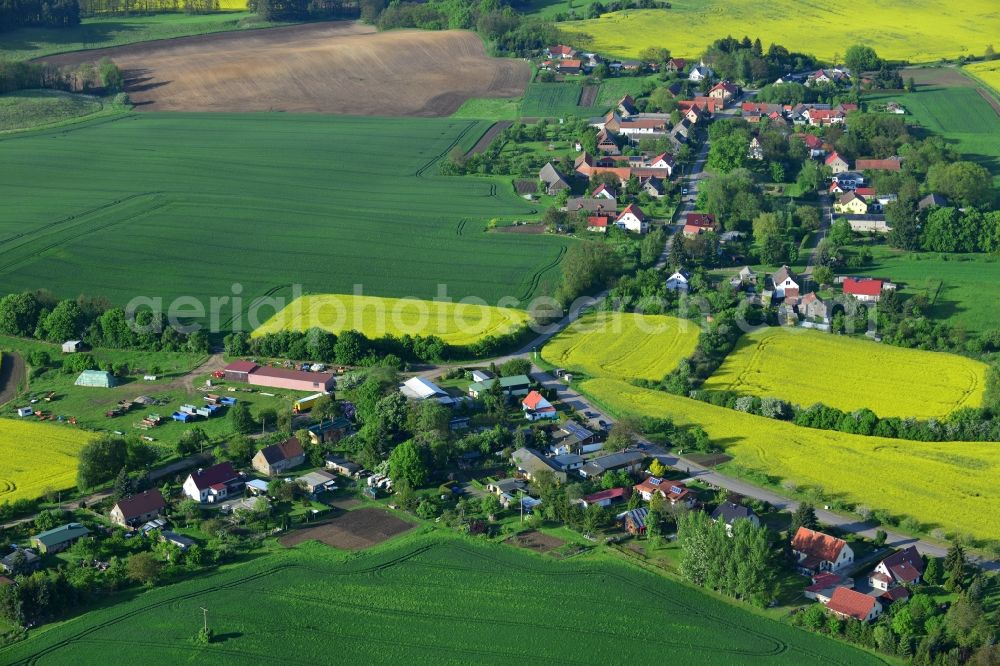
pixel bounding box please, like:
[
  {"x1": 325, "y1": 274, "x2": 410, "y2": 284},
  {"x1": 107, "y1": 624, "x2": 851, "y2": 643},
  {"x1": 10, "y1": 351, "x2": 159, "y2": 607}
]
[{"x1": 0, "y1": 419, "x2": 91, "y2": 502}]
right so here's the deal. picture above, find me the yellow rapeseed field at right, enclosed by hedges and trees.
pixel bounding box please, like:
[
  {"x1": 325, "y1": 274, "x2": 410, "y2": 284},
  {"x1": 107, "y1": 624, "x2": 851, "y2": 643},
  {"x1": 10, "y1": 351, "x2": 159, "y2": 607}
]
[{"x1": 704, "y1": 328, "x2": 987, "y2": 419}]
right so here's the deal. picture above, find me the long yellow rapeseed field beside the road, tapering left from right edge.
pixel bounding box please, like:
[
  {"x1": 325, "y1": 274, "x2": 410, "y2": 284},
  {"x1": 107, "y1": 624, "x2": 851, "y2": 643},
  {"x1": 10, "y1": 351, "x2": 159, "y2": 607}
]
[{"x1": 580, "y1": 379, "x2": 1000, "y2": 539}]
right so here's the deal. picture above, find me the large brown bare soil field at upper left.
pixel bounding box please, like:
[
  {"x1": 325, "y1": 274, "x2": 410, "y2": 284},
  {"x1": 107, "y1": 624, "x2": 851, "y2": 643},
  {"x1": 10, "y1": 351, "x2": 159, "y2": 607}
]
[{"x1": 44, "y1": 22, "x2": 531, "y2": 116}]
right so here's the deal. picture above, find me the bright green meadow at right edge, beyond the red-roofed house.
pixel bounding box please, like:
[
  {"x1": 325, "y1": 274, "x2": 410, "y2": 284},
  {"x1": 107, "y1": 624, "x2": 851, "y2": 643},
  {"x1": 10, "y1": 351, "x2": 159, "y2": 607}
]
[{"x1": 848, "y1": 246, "x2": 1000, "y2": 332}]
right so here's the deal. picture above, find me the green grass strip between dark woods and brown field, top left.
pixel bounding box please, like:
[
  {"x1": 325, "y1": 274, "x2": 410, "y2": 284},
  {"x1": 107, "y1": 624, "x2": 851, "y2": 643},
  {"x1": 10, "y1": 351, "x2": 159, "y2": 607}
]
[{"x1": 3, "y1": 11, "x2": 274, "y2": 60}]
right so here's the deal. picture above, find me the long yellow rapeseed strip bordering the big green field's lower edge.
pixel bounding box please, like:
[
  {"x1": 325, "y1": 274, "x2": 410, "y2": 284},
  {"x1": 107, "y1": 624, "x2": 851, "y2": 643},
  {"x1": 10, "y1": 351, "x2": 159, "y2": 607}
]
[{"x1": 253, "y1": 294, "x2": 531, "y2": 345}]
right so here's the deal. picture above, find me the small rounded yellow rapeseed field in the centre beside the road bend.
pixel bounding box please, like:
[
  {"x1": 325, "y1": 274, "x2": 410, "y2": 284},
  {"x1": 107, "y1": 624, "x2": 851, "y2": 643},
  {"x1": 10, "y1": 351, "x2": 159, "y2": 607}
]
[{"x1": 542, "y1": 312, "x2": 700, "y2": 381}]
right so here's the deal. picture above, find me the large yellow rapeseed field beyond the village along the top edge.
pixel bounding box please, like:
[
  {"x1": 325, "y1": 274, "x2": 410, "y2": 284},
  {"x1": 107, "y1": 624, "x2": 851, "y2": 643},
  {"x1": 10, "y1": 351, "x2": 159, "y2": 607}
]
[{"x1": 559, "y1": 0, "x2": 1000, "y2": 62}]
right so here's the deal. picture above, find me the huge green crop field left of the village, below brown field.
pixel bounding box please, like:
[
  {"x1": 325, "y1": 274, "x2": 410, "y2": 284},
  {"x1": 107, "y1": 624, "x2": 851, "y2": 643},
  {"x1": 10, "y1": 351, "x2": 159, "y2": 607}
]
[{"x1": 0, "y1": 113, "x2": 572, "y2": 320}]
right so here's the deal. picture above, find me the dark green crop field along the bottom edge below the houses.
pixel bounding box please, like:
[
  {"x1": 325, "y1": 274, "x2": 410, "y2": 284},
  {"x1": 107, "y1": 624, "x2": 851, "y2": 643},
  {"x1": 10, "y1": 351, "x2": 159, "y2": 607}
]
[{"x1": 0, "y1": 533, "x2": 882, "y2": 666}]
